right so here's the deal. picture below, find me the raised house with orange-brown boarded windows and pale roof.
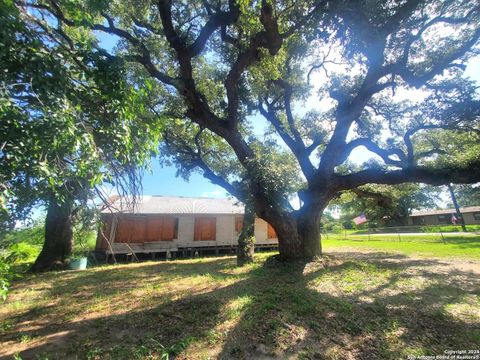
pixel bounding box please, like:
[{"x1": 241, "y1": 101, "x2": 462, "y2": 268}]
[{"x1": 96, "y1": 196, "x2": 278, "y2": 258}]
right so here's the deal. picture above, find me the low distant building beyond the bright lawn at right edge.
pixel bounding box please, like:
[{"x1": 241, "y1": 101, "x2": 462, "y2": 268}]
[{"x1": 408, "y1": 206, "x2": 480, "y2": 225}]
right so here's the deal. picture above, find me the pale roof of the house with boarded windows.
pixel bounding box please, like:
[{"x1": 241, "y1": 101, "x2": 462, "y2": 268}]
[{"x1": 101, "y1": 195, "x2": 244, "y2": 214}]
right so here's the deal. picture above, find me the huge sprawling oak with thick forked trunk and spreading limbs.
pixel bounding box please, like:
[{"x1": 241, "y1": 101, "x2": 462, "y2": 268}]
[{"x1": 13, "y1": 0, "x2": 480, "y2": 259}]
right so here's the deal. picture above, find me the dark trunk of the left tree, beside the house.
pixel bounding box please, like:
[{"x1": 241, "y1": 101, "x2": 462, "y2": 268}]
[{"x1": 30, "y1": 198, "x2": 73, "y2": 272}]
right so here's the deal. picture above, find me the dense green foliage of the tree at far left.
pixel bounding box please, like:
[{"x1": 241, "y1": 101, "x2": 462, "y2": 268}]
[{"x1": 0, "y1": 4, "x2": 159, "y2": 215}]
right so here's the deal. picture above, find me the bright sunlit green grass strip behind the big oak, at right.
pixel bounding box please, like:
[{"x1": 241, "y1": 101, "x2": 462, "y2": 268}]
[{"x1": 322, "y1": 234, "x2": 480, "y2": 259}]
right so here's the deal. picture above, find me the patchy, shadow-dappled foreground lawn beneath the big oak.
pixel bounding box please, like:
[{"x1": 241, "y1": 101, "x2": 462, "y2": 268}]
[{"x1": 0, "y1": 240, "x2": 480, "y2": 359}]
